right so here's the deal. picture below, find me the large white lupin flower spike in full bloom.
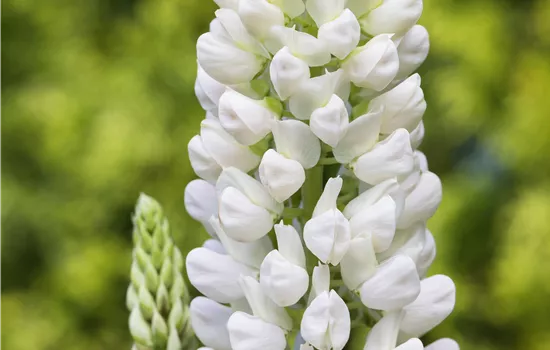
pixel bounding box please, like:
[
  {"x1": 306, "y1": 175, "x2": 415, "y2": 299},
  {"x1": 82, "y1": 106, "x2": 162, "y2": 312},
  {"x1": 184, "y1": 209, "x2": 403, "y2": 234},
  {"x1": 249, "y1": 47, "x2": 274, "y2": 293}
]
[{"x1": 185, "y1": 0, "x2": 458, "y2": 350}]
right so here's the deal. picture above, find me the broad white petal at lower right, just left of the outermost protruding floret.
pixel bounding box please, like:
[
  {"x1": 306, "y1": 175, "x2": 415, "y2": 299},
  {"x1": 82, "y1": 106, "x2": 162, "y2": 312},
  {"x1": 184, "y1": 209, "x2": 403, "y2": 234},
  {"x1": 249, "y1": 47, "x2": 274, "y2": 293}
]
[{"x1": 361, "y1": 255, "x2": 420, "y2": 310}]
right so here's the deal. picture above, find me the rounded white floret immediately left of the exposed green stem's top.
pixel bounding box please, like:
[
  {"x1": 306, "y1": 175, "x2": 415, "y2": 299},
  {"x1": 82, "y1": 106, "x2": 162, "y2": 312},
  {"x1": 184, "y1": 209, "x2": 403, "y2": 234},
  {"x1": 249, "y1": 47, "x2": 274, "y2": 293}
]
[{"x1": 259, "y1": 149, "x2": 306, "y2": 203}]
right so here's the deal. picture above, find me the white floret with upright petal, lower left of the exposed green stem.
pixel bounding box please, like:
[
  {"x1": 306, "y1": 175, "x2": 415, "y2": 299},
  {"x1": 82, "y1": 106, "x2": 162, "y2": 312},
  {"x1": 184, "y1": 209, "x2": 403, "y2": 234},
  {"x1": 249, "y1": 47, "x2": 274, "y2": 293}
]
[{"x1": 260, "y1": 222, "x2": 309, "y2": 307}]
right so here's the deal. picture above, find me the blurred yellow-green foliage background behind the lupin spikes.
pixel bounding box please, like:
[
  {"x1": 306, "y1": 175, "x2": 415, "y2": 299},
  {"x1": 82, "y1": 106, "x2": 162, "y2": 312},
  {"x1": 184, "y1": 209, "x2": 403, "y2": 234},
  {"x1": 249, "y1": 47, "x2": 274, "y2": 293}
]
[{"x1": 0, "y1": 0, "x2": 550, "y2": 350}]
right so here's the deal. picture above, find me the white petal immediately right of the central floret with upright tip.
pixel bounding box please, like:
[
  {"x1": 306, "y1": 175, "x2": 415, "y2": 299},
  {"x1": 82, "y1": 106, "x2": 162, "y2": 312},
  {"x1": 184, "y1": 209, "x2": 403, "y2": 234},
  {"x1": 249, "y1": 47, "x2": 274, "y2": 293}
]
[{"x1": 349, "y1": 195, "x2": 396, "y2": 252}]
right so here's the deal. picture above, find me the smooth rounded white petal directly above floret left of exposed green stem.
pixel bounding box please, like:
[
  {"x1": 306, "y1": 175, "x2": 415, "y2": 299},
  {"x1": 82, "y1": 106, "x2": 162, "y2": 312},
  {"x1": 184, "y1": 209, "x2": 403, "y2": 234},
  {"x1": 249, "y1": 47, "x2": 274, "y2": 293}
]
[{"x1": 273, "y1": 120, "x2": 321, "y2": 169}]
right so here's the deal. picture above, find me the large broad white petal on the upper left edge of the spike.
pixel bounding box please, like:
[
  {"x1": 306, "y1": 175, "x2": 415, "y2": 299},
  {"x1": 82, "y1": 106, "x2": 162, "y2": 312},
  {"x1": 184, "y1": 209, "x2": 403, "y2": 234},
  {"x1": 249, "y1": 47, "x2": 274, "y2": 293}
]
[{"x1": 197, "y1": 33, "x2": 265, "y2": 84}]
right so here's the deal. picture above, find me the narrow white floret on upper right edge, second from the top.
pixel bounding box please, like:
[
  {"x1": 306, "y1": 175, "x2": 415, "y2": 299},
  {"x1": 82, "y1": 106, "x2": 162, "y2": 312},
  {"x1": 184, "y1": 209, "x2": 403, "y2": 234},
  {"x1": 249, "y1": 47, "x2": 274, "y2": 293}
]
[{"x1": 397, "y1": 24, "x2": 430, "y2": 79}]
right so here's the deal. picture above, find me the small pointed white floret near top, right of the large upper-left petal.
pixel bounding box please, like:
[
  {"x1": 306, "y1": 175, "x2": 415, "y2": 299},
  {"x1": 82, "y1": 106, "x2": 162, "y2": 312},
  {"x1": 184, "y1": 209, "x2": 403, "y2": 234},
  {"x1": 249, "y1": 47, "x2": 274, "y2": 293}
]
[{"x1": 269, "y1": 46, "x2": 310, "y2": 100}]
